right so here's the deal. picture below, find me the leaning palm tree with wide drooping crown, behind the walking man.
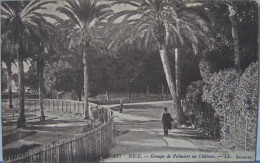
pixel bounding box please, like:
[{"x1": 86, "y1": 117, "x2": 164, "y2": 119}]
[{"x1": 109, "y1": 0, "x2": 209, "y2": 122}]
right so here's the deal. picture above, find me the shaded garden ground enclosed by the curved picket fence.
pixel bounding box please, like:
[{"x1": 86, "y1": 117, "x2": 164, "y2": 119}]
[{"x1": 2, "y1": 110, "x2": 95, "y2": 159}]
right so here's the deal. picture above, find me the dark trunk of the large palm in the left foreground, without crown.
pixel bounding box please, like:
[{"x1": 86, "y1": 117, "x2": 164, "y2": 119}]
[{"x1": 17, "y1": 54, "x2": 26, "y2": 128}]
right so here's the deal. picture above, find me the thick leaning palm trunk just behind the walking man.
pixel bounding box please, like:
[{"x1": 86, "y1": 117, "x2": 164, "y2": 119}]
[{"x1": 159, "y1": 45, "x2": 184, "y2": 123}]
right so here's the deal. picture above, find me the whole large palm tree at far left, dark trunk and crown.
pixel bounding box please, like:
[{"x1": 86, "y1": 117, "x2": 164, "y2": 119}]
[{"x1": 1, "y1": 0, "x2": 58, "y2": 128}]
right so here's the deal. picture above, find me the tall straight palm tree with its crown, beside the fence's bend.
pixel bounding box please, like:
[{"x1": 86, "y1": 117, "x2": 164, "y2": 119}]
[{"x1": 57, "y1": 0, "x2": 112, "y2": 119}]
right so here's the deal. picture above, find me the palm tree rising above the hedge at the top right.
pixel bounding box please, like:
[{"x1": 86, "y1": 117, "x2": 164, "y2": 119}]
[{"x1": 201, "y1": 1, "x2": 257, "y2": 71}]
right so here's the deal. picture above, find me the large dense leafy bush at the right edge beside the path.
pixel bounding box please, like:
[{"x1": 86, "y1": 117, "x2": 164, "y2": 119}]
[{"x1": 202, "y1": 63, "x2": 258, "y2": 150}]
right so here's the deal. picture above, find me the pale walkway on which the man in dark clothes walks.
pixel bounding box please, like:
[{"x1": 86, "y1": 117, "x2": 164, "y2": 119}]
[{"x1": 101, "y1": 101, "x2": 217, "y2": 162}]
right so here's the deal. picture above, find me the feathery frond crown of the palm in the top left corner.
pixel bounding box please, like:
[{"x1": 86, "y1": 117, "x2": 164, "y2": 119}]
[{"x1": 1, "y1": 0, "x2": 58, "y2": 58}]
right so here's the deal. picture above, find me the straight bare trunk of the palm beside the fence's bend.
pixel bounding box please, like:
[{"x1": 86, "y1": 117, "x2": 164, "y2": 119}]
[{"x1": 83, "y1": 47, "x2": 90, "y2": 119}]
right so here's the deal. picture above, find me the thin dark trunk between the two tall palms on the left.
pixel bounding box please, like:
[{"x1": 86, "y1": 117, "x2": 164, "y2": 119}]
[{"x1": 37, "y1": 59, "x2": 45, "y2": 121}]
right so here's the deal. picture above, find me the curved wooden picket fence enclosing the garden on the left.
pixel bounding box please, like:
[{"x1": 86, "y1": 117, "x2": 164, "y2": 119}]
[{"x1": 2, "y1": 99, "x2": 113, "y2": 163}]
